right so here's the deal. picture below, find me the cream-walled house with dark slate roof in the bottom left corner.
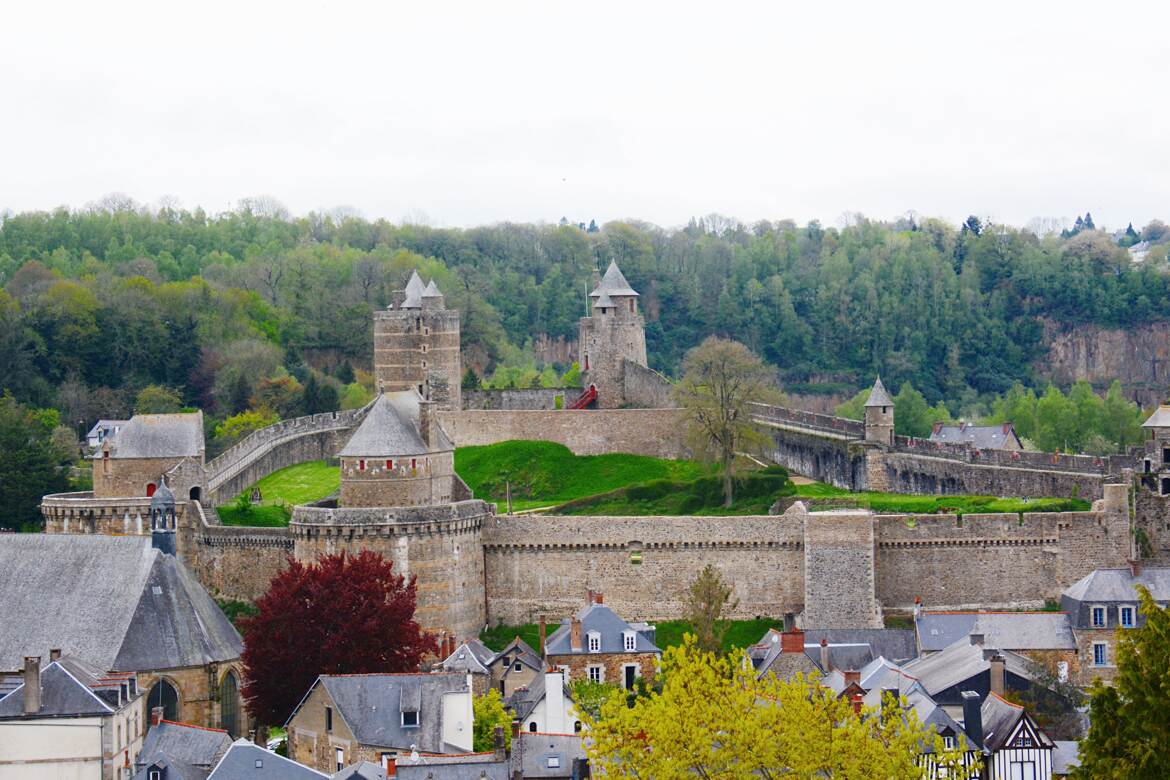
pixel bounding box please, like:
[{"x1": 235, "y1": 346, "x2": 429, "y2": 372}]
[{"x1": 0, "y1": 656, "x2": 145, "y2": 780}]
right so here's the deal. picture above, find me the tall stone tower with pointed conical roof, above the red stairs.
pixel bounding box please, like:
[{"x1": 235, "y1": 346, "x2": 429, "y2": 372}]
[{"x1": 579, "y1": 261, "x2": 647, "y2": 408}]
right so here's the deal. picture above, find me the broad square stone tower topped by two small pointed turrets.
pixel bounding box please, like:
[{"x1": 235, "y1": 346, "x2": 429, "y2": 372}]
[{"x1": 373, "y1": 271, "x2": 462, "y2": 410}]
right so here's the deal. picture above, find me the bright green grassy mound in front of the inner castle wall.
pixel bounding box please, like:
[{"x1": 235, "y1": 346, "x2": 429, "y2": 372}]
[{"x1": 455, "y1": 441, "x2": 710, "y2": 510}]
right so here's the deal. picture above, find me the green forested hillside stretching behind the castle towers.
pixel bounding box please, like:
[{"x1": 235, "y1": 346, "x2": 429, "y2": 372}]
[{"x1": 0, "y1": 200, "x2": 1170, "y2": 421}]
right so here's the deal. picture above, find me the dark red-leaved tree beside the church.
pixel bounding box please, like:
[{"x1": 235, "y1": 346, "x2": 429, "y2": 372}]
[{"x1": 241, "y1": 550, "x2": 439, "y2": 724}]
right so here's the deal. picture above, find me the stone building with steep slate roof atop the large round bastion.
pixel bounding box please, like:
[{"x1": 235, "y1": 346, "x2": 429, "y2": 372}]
[{"x1": 339, "y1": 389, "x2": 466, "y2": 506}]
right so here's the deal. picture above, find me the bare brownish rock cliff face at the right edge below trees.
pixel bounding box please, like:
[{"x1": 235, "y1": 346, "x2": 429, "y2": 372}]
[{"x1": 1035, "y1": 322, "x2": 1170, "y2": 406}]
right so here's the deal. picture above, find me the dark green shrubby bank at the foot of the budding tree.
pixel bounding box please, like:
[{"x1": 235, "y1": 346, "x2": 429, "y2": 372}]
[{"x1": 553, "y1": 465, "x2": 794, "y2": 515}]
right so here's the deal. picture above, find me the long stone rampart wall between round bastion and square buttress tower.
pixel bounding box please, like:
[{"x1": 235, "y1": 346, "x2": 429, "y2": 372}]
[{"x1": 483, "y1": 516, "x2": 804, "y2": 624}]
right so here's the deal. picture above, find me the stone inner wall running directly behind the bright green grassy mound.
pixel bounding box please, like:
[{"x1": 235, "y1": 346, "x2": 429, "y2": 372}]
[{"x1": 439, "y1": 409, "x2": 689, "y2": 458}]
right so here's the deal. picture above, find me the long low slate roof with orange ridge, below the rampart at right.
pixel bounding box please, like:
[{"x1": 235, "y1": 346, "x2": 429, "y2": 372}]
[{"x1": 914, "y1": 612, "x2": 1076, "y2": 653}]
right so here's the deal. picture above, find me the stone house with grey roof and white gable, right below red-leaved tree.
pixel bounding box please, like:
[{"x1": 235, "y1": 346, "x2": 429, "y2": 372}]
[{"x1": 284, "y1": 672, "x2": 473, "y2": 774}]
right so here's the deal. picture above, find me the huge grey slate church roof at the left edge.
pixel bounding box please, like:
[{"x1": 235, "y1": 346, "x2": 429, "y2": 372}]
[{"x1": 0, "y1": 533, "x2": 243, "y2": 671}]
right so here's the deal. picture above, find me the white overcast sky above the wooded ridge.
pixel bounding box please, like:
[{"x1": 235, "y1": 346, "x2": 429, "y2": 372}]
[{"x1": 0, "y1": 0, "x2": 1170, "y2": 227}]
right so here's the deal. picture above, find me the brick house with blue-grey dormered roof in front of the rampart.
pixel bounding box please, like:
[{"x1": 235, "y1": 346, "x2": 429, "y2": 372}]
[{"x1": 544, "y1": 593, "x2": 662, "y2": 689}]
